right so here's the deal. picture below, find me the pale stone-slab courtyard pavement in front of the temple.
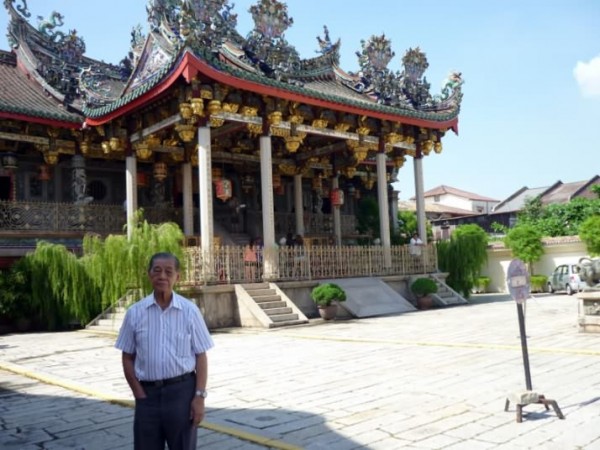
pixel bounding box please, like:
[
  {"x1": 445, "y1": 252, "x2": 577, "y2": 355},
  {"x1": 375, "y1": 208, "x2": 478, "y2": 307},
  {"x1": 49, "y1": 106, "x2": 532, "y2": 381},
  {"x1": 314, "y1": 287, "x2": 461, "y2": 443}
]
[{"x1": 0, "y1": 294, "x2": 600, "y2": 450}]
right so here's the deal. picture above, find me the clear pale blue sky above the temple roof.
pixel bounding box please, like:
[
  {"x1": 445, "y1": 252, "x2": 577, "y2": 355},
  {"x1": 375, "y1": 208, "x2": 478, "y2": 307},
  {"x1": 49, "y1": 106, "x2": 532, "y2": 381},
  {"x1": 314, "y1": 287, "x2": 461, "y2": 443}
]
[{"x1": 0, "y1": 0, "x2": 600, "y2": 200}]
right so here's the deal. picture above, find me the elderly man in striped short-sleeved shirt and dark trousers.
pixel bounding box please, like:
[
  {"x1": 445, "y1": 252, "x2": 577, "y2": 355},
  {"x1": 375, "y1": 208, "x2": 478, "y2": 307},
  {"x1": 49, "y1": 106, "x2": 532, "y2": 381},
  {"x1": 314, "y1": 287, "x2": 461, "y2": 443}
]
[{"x1": 115, "y1": 253, "x2": 214, "y2": 450}]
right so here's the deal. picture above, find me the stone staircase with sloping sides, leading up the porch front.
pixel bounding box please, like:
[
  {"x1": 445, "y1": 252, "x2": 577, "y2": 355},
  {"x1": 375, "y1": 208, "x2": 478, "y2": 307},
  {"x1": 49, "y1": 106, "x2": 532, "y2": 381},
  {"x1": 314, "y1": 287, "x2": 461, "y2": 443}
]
[{"x1": 235, "y1": 283, "x2": 308, "y2": 328}]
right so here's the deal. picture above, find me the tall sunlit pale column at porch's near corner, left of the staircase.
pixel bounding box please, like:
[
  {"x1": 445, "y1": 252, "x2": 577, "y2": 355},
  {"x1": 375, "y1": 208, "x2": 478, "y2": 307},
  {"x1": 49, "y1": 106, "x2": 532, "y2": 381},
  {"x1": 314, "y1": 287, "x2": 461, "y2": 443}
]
[{"x1": 198, "y1": 126, "x2": 215, "y2": 281}]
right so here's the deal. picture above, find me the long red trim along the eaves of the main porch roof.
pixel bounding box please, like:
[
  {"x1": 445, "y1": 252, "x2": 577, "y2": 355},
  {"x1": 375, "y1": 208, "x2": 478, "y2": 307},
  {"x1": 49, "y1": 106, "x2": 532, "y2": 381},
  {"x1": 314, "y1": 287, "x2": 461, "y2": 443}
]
[{"x1": 86, "y1": 51, "x2": 458, "y2": 134}]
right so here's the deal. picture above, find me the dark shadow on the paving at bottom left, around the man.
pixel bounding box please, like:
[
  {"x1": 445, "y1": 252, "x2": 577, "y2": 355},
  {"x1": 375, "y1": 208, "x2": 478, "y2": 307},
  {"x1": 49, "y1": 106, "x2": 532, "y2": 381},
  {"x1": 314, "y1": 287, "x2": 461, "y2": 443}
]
[{"x1": 0, "y1": 378, "x2": 359, "y2": 450}]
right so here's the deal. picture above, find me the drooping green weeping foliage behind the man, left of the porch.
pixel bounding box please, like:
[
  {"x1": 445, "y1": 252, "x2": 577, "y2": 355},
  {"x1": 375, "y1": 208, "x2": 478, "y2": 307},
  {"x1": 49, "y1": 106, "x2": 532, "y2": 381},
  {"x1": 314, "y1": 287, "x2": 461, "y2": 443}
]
[{"x1": 19, "y1": 216, "x2": 184, "y2": 329}]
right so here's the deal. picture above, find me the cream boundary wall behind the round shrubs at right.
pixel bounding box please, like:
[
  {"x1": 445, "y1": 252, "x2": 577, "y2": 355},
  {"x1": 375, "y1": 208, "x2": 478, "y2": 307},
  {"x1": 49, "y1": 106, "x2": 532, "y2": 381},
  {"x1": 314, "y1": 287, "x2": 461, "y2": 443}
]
[{"x1": 481, "y1": 238, "x2": 589, "y2": 292}]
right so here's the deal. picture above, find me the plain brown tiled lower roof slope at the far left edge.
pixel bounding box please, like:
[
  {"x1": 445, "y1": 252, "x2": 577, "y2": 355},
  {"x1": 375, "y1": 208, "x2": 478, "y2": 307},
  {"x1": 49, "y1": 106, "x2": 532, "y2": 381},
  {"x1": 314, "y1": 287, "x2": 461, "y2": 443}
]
[{"x1": 0, "y1": 51, "x2": 84, "y2": 124}]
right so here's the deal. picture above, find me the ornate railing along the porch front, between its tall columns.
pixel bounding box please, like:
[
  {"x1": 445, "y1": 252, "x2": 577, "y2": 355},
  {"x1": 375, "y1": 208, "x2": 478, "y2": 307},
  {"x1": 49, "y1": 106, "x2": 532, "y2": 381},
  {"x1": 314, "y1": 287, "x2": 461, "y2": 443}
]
[{"x1": 181, "y1": 244, "x2": 437, "y2": 285}]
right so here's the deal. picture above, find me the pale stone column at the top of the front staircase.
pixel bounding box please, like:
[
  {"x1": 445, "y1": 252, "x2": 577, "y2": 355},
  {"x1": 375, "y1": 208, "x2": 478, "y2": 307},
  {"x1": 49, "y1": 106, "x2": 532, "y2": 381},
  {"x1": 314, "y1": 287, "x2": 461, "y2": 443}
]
[{"x1": 260, "y1": 136, "x2": 277, "y2": 280}]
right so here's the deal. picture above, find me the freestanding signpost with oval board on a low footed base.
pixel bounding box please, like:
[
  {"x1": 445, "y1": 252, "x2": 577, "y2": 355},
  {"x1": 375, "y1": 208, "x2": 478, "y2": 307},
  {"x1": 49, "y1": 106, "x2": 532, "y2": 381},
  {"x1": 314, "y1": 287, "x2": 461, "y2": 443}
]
[{"x1": 504, "y1": 259, "x2": 565, "y2": 423}]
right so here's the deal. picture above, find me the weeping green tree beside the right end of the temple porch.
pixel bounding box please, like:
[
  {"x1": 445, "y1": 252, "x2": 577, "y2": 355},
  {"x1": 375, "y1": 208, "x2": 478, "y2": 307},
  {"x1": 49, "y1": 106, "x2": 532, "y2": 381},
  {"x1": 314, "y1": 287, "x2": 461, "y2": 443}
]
[{"x1": 437, "y1": 224, "x2": 488, "y2": 298}]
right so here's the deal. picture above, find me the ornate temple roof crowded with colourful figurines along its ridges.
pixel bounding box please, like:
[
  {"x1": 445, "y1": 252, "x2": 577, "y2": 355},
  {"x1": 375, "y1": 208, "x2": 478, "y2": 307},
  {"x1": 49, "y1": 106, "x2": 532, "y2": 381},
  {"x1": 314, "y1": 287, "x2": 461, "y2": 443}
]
[{"x1": 4, "y1": 0, "x2": 462, "y2": 130}]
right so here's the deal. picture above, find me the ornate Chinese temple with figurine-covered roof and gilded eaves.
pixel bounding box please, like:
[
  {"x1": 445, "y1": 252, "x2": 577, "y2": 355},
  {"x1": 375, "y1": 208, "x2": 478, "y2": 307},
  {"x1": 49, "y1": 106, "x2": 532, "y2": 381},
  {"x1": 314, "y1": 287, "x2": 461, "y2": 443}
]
[{"x1": 0, "y1": 0, "x2": 462, "y2": 277}]
